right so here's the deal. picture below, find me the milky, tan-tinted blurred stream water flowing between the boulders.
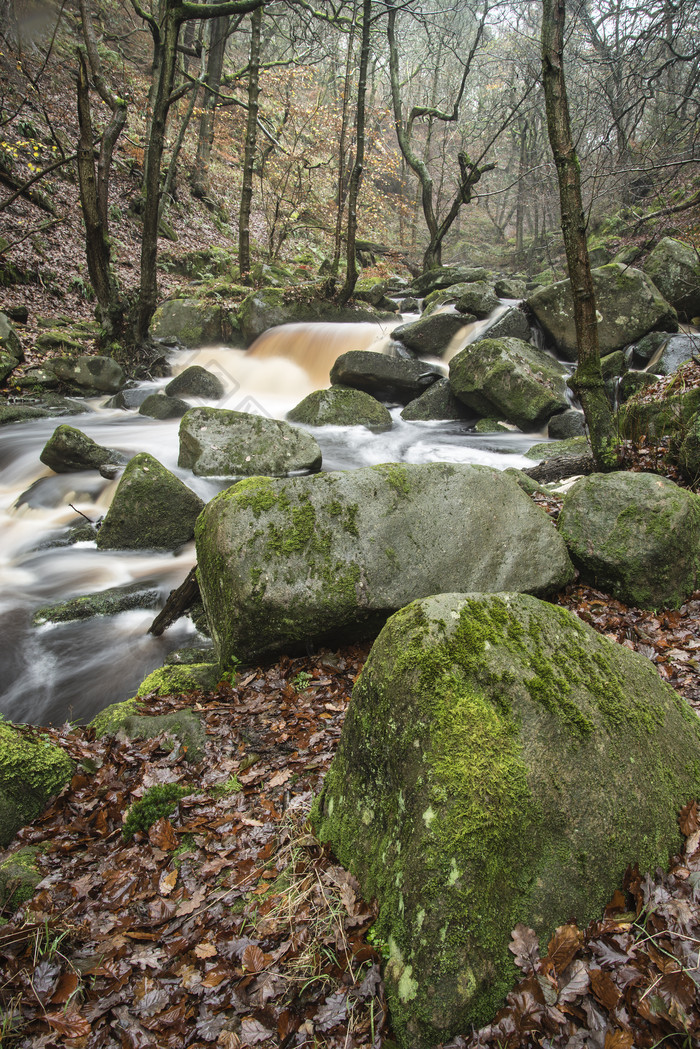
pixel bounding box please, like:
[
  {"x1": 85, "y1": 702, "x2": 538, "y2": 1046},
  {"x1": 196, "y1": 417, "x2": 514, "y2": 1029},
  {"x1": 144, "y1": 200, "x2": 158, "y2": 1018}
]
[{"x1": 0, "y1": 324, "x2": 540, "y2": 724}]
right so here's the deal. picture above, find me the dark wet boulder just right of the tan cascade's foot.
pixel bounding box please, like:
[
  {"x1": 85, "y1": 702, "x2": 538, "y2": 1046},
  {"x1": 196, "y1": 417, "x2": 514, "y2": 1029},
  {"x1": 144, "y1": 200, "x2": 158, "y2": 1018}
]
[{"x1": 331, "y1": 349, "x2": 442, "y2": 404}]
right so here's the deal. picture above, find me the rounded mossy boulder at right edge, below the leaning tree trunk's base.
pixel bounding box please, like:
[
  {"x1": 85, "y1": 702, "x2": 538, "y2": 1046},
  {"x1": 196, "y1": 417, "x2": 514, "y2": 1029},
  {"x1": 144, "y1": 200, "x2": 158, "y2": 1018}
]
[{"x1": 558, "y1": 472, "x2": 700, "y2": 608}]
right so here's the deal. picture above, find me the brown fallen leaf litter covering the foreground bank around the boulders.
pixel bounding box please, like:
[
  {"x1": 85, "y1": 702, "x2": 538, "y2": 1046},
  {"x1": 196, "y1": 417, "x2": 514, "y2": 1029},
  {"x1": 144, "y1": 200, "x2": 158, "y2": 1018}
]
[{"x1": 0, "y1": 612, "x2": 700, "y2": 1049}]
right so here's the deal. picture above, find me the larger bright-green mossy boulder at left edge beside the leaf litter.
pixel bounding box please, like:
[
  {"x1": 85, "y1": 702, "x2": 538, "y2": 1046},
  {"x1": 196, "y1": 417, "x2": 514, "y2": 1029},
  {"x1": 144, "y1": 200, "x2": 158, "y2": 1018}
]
[{"x1": 0, "y1": 722, "x2": 75, "y2": 849}]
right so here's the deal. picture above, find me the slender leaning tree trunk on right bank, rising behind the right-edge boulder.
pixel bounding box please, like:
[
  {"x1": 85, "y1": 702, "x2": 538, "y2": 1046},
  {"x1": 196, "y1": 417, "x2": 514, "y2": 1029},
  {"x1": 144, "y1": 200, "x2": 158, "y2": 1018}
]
[{"x1": 542, "y1": 0, "x2": 615, "y2": 469}]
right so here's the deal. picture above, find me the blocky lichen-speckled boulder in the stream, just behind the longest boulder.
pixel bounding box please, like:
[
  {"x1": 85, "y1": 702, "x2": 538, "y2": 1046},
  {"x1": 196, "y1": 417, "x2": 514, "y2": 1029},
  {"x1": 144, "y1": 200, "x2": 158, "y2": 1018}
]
[{"x1": 177, "y1": 405, "x2": 323, "y2": 477}]
